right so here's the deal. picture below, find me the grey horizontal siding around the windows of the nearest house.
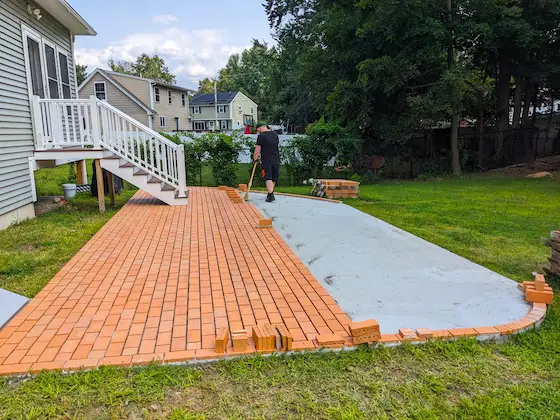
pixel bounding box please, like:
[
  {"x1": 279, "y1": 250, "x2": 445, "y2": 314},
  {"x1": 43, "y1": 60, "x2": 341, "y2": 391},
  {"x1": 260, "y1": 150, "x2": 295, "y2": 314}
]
[{"x1": 0, "y1": 0, "x2": 76, "y2": 220}]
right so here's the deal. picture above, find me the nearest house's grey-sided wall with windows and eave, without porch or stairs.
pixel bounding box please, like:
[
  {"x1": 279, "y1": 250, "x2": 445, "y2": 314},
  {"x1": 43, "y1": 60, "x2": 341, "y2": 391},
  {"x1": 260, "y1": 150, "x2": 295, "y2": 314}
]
[{"x1": 0, "y1": 0, "x2": 96, "y2": 229}]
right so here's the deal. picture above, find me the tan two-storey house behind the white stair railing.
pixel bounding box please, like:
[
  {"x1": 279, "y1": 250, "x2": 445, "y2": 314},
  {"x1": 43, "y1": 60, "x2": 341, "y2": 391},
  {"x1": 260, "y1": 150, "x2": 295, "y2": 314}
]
[{"x1": 78, "y1": 69, "x2": 191, "y2": 131}]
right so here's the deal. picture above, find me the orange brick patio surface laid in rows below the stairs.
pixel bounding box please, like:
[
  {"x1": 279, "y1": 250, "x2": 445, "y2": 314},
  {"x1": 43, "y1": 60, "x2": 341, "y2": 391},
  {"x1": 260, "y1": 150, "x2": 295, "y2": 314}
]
[{"x1": 0, "y1": 188, "x2": 351, "y2": 374}]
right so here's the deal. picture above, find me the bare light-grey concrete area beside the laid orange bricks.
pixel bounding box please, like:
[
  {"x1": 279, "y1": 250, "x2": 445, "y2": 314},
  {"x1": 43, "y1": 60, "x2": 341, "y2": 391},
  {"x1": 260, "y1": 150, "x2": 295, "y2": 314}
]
[{"x1": 250, "y1": 194, "x2": 530, "y2": 333}]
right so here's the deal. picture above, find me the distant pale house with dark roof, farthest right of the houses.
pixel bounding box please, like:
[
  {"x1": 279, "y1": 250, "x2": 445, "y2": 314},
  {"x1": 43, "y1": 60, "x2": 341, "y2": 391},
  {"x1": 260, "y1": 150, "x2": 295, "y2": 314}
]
[{"x1": 190, "y1": 92, "x2": 258, "y2": 131}]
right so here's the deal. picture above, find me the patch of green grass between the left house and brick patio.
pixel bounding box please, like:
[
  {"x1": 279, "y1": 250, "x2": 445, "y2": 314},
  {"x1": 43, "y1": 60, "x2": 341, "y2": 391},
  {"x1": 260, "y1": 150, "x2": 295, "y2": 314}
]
[{"x1": 0, "y1": 190, "x2": 134, "y2": 297}]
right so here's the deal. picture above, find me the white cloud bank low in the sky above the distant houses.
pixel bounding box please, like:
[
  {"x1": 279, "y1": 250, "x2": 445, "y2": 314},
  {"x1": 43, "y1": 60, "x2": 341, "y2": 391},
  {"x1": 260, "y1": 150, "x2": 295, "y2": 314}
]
[{"x1": 76, "y1": 27, "x2": 249, "y2": 87}]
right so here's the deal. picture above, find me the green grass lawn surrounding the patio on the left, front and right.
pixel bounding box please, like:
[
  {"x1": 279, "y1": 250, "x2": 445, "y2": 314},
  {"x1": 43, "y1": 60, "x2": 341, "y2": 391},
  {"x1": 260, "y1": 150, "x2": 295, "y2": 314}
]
[{"x1": 0, "y1": 177, "x2": 560, "y2": 419}]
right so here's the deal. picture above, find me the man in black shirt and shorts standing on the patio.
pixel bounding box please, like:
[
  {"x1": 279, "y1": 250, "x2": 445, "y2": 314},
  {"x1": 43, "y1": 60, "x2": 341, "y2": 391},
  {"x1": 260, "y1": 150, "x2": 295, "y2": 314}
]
[{"x1": 253, "y1": 122, "x2": 280, "y2": 203}]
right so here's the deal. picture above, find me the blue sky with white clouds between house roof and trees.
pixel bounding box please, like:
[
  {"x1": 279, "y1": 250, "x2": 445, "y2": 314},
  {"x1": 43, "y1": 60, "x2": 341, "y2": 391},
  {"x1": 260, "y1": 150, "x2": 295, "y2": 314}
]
[{"x1": 70, "y1": 0, "x2": 273, "y2": 88}]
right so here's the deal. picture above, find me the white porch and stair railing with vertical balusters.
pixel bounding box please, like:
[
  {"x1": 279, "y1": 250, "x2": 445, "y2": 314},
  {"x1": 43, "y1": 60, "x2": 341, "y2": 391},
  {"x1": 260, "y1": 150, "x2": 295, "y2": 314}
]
[{"x1": 32, "y1": 96, "x2": 187, "y2": 197}]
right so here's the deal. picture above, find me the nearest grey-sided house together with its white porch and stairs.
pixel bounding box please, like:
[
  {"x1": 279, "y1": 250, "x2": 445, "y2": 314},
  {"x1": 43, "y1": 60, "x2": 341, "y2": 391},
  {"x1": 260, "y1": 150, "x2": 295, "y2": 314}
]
[{"x1": 0, "y1": 0, "x2": 188, "y2": 229}]
